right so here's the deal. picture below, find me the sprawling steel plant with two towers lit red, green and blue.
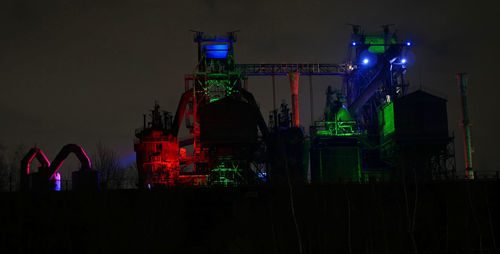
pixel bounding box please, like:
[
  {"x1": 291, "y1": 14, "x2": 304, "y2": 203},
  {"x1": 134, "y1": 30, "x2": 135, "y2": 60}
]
[{"x1": 135, "y1": 26, "x2": 455, "y2": 188}]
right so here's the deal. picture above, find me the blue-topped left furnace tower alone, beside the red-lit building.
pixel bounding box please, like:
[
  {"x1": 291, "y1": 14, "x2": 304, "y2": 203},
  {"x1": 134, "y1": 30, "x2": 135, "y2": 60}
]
[{"x1": 172, "y1": 32, "x2": 268, "y2": 186}]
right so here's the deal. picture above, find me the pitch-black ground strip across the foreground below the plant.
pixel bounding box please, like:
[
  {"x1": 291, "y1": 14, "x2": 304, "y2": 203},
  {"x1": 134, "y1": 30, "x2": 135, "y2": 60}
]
[{"x1": 0, "y1": 181, "x2": 500, "y2": 253}]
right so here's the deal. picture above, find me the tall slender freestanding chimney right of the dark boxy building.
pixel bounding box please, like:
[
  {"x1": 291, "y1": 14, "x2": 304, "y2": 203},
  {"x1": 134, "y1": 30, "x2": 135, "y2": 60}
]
[{"x1": 457, "y1": 73, "x2": 474, "y2": 180}]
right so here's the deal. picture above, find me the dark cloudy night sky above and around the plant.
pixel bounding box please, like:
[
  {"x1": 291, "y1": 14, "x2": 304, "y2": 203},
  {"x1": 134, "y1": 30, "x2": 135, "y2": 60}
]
[{"x1": 0, "y1": 0, "x2": 500, "y2": 175}]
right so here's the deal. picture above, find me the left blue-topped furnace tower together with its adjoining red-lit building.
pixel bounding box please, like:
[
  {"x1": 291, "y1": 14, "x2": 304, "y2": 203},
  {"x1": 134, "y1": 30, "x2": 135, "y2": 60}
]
[{"x1": 135, "y1": 32, "x2": 267, "y2": 188}]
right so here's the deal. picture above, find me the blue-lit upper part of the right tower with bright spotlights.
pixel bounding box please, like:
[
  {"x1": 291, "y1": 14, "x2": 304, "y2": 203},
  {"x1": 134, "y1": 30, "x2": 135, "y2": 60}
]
[{"x1": 342, "y1": 26, "x2": 411, "y2": 133}]
